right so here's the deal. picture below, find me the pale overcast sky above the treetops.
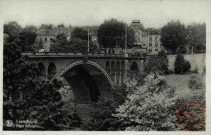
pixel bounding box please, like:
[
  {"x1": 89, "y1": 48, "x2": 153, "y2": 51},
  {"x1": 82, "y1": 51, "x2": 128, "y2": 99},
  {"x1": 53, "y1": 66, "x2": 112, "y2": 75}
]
[{"x1": 3, "y1": 0, "x2": 211, "y2": 28}]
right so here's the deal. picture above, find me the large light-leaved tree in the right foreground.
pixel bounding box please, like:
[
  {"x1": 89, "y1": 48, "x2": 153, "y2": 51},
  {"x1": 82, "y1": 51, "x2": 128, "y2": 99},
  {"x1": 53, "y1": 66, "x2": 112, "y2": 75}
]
[{"x1": 113, "y1": 73, "x2": 178, "y2": 131}]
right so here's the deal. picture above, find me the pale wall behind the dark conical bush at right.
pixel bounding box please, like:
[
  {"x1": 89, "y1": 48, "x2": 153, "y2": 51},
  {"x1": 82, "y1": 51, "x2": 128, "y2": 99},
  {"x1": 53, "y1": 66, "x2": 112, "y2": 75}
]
[{"x1": 167, "y1": 53, "x2": 206, "y2": 73}]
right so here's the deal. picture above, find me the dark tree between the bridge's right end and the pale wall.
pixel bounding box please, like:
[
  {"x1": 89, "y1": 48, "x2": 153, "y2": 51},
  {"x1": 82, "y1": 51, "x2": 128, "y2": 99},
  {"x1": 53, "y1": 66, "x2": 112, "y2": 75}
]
[{"x1": 145, "y1": 50, "x2": 168, "y2": 74}]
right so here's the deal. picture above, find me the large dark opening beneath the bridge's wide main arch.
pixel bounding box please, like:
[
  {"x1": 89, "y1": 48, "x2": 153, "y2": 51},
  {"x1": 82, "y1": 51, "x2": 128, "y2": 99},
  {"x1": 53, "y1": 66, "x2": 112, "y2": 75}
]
[{"x1": 59, "y1": 61, "x2": 113, "y2": 104}]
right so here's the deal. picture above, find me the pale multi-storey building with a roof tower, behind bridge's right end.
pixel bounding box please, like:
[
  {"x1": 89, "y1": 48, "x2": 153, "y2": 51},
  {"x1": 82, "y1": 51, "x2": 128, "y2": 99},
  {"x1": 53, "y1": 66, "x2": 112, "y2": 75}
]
[{"x1": 130, "y1": 20, "x2": 161, "y2": 55}]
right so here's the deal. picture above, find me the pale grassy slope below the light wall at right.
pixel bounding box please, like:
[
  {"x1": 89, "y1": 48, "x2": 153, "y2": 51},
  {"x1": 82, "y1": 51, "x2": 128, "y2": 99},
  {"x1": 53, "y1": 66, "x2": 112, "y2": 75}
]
[{"x1": 166, "y1": 74, "x2": 205, "y2": 97}]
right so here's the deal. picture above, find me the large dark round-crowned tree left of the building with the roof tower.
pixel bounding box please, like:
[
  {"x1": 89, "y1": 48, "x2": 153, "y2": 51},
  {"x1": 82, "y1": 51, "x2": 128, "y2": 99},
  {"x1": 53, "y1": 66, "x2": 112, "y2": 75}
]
[{"x1": 98, "y1": 19, "x2": 135, "y2": 48}]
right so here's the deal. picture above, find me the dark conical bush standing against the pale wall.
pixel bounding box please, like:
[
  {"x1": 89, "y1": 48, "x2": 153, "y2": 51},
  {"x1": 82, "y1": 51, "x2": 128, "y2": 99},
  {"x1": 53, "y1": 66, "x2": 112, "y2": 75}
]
[{"x1": 174, "y1": 53, "x2": 191, "y2": 74}]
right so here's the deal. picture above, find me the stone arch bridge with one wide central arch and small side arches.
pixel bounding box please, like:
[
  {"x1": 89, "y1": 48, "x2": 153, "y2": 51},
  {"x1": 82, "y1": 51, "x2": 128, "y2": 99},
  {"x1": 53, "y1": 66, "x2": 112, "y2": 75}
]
[{"x1": 22, "y1": 52, "x2": 146, "y2": 103}]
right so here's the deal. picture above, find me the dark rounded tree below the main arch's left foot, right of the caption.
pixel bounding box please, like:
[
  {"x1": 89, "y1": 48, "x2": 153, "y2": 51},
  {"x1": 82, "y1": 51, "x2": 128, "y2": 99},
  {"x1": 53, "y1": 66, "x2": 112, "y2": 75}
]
[{"x1": 27, "y1": 80, "x2": 68, "y2": 130}]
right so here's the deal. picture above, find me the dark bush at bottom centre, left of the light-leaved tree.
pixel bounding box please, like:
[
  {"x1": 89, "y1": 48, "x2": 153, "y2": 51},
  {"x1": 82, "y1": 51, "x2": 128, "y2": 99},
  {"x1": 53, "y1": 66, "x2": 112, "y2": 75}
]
[{"x1": 81, "y1": 87, "x2": 127, "y2": 131}]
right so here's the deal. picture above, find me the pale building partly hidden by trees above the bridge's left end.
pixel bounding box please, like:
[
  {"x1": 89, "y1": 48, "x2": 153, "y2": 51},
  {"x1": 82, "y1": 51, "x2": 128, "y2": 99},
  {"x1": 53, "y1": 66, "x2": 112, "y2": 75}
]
[{"x1": 37, "y1": 27, "x2": 72, "y2": 52}]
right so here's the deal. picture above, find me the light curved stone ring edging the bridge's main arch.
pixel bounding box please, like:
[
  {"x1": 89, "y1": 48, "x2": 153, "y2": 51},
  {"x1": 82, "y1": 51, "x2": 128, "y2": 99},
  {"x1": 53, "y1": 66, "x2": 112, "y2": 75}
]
[{"x1": 54, "y1": 60, "x2": 114, "y2": 87}]
